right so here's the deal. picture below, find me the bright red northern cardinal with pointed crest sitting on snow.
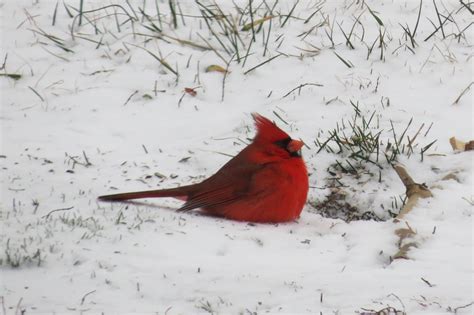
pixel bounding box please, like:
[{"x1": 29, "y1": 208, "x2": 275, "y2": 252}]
[{"x1": 99, "y1": 114, "x2": 308, "y2": 223}]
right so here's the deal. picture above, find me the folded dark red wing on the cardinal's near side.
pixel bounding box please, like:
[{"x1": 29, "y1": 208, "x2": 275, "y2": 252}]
[{"x1": 178, "y1": 164, "x2": 268, "y2": 211}]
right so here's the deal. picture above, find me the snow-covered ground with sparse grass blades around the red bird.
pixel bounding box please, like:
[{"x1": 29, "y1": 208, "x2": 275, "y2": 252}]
[{"x1": 0, "y1": 0, "x2": 474, "y2": 315}]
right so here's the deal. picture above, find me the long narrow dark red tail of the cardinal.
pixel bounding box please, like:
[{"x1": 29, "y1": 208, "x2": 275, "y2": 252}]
[{"x1": 98, "y1": 185, "x2": 194, "y2": 201}]
